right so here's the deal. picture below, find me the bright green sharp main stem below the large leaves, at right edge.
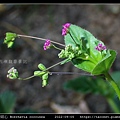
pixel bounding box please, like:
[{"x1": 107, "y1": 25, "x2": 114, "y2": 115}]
[{"x1": 104, "y1": 72, "x2": 120, "y2": 100}]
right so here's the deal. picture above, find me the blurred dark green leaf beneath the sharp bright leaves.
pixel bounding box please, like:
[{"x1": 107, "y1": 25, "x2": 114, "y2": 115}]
[{"x1": 63, "y1": 76, "x2": 115, "y2": 97}]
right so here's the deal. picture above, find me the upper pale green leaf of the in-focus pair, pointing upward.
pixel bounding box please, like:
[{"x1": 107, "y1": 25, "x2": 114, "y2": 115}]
[{"x1": 64, "y1": 24, "x2": 104, "y2": 60}]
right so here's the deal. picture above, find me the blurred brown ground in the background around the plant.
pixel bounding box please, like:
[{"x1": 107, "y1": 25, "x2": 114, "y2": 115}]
[{"x1": 0, "y1": 3, "x2": 120, "y2": 113}]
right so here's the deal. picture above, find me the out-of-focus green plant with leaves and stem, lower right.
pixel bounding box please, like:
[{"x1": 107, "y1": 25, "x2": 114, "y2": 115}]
[{"x1": 63, "y1": 71, "x2": 120, "y2": 113}]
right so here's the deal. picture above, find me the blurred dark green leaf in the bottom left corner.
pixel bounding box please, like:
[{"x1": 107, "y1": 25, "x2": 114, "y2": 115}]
[{"x1": 0, "y1": 91, "x2": 16, "y2": 113}]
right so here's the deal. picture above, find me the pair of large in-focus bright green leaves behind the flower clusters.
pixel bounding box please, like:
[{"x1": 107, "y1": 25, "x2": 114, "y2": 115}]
[{"x1": 64, "y1": 24, "x2": 116, "y2": 75}]
